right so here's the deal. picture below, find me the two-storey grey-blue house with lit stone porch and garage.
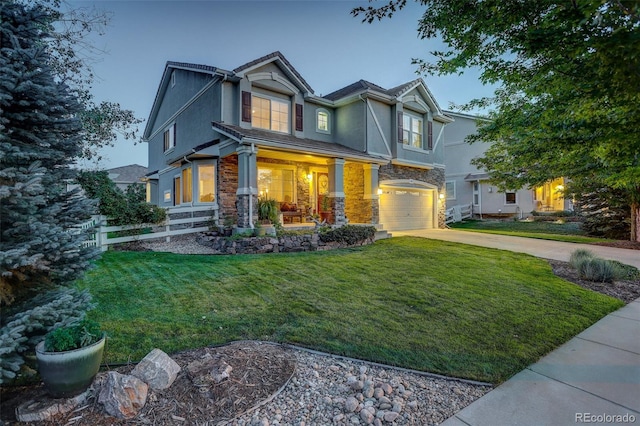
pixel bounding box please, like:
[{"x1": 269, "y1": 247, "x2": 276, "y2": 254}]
[{"x1": 143, "y1": 52, "x2": 453, "y2": 230}]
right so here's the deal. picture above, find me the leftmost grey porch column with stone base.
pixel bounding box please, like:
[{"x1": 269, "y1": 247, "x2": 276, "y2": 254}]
[{"x1": 236, "y1": 145, "x2": 258, "y2": 231}]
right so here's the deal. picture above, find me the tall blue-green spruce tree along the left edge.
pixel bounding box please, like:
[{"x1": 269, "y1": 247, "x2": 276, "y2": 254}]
[{"x1": 0, "y1": 0, "x2": 98, "y2": 383}]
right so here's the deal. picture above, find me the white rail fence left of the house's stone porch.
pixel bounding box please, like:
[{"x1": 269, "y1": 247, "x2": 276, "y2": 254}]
[{"x1": 81, "y1": 207, "x2": 213, "y2": 251}]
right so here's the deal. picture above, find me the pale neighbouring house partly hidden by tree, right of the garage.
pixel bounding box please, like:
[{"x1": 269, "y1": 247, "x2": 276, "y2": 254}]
[{"x1": 444, "y1": 111, "x2": 571, "y2": 217}]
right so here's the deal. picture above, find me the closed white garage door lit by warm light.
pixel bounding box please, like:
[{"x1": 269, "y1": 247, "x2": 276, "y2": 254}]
[{"x1": 380, "y1": 187, "x2": 434, "y2": 231}]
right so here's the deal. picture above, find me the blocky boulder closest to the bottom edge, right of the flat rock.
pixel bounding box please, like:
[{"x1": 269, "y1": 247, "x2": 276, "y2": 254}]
[{"x1": 98, "y1": 371, "x2": 149, "y2": 419}]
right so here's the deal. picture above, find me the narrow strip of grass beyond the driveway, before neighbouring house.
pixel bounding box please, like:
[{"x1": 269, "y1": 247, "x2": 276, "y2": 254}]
[{"x1": 449, "y1": 220, "x2": 611, "y2": 244}]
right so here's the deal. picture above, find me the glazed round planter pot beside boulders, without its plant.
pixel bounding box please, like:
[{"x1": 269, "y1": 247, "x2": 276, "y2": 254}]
[{"x1": 36, "y1": 335, "x2": 106, "y2": 398}]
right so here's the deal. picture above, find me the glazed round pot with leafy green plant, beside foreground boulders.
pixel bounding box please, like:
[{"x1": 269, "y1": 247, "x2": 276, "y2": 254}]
[{"x1": 36, "y1": 318, "x2": 106, "y2": 398}]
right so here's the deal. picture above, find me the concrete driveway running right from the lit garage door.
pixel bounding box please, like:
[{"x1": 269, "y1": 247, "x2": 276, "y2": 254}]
[{"x1": 393, "y1": 229, "x2": 640, "y2": 268}]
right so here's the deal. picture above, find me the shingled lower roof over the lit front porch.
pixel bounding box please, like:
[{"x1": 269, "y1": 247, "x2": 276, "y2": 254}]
[{"x1": 211, "y1": 121, "x2": 388, "y2": 163}]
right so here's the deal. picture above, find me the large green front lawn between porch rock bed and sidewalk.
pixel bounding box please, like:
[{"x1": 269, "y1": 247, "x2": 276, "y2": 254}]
[{"x1": 79, "y1": 237, "x2": 623, "y2": 383}]
